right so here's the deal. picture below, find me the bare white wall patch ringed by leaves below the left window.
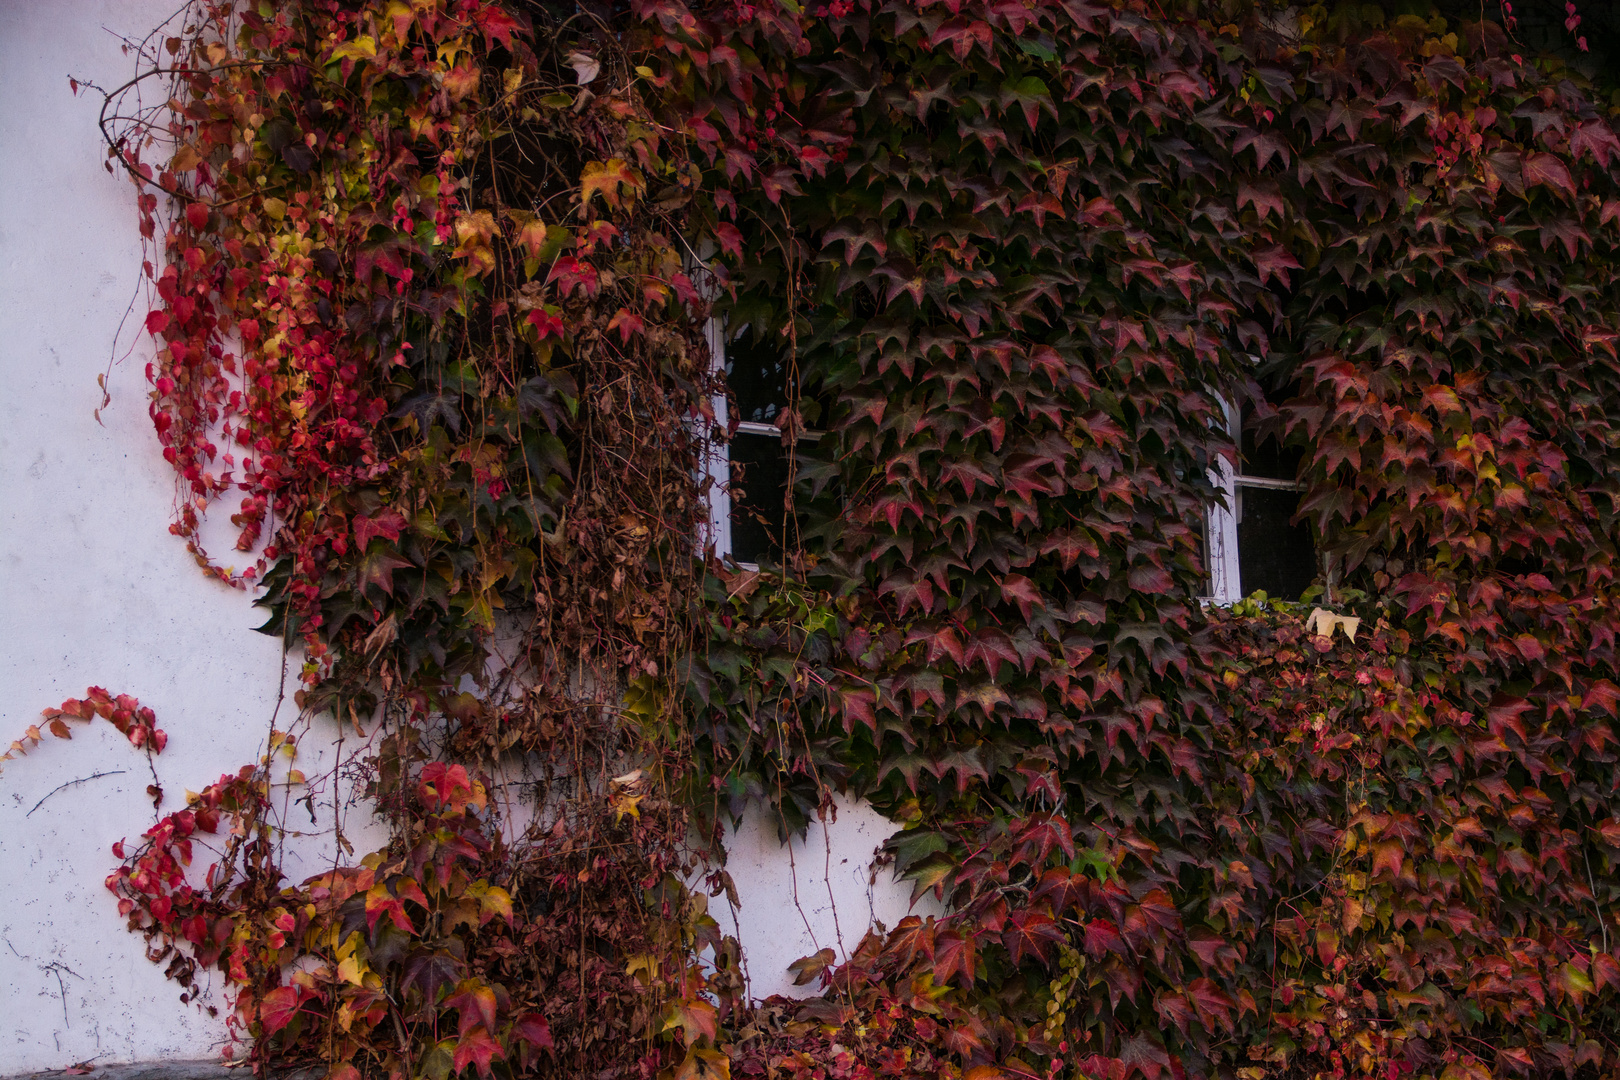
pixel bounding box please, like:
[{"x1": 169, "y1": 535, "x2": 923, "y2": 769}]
[{"x1": 710, "y1": 795, "x2": 944, "y2": 999}]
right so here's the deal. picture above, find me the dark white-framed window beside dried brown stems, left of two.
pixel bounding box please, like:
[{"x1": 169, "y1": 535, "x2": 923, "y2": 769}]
[{"x1": 706, "y1": 319, "x2": 820, "y2": 567}]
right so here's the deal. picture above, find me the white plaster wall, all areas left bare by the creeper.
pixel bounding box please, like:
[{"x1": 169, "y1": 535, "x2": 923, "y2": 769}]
[{"x1": 0, "y1": 0, "x2": 932, "y2": 1077}]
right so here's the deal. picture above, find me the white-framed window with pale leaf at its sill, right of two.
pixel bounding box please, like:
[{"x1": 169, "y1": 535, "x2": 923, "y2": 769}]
[{"x1": 1205, "y1": 396, "x2": 1317, "y2": 604}]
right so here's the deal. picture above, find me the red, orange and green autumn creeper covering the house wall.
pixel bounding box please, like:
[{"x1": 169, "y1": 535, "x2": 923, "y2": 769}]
[{"x1": 66, "y1": 0, "x2": 1620, "y2": 1080}]
